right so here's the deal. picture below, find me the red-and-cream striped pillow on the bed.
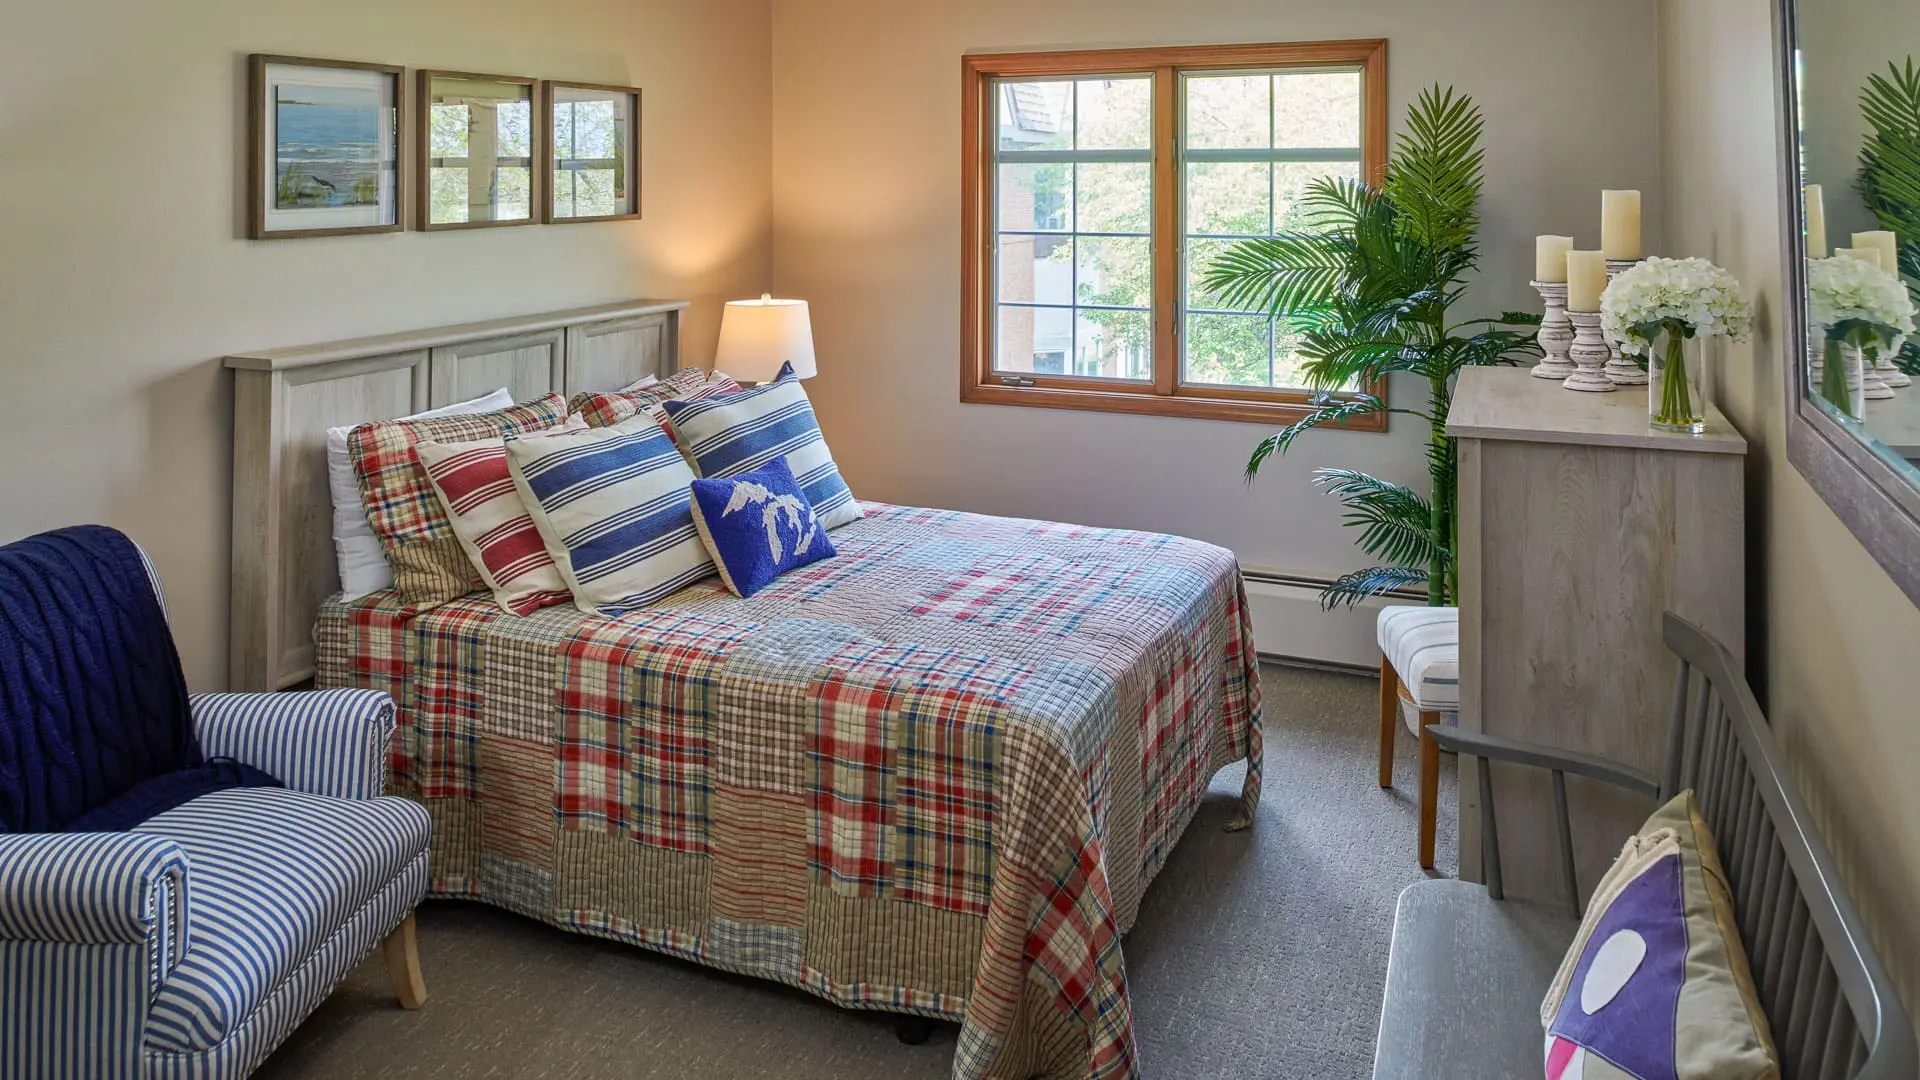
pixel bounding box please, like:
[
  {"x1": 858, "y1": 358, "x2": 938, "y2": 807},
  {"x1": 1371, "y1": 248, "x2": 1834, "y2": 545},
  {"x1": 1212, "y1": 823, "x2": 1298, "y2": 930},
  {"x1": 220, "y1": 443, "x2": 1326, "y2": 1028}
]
[{"x1": 415, "y1": 417, "x2": 588, "y2": 615}]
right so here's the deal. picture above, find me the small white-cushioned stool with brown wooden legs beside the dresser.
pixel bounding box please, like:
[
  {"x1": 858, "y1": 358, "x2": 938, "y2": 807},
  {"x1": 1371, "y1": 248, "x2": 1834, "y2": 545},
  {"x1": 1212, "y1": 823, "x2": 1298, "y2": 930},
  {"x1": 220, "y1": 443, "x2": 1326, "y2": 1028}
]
[{"x1": 1377, "y1": 605, "x2": 1459, "y2": 871}]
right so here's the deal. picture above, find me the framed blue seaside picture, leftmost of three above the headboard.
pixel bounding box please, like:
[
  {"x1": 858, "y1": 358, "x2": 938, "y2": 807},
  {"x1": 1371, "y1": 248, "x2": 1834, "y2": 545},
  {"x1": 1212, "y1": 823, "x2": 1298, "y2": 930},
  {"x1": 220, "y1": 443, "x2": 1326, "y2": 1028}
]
[{"x1": 248, "y1": 56, "x2": 407, "y2": 240}]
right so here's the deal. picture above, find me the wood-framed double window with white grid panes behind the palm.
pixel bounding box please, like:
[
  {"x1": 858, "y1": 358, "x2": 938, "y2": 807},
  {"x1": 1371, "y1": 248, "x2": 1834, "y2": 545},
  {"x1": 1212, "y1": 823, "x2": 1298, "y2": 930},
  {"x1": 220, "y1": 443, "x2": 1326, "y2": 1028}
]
[{"x1": 960, "y1": 40, "x2": 1386, "y2": 430}]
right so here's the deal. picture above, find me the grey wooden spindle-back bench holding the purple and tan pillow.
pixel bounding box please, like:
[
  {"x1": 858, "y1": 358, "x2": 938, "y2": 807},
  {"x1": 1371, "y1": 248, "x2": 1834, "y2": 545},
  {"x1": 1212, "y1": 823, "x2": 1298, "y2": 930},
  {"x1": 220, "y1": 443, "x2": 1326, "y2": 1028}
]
[{"x1": 1375, "y1": 613, "x2": 1920, "y2": 1080}]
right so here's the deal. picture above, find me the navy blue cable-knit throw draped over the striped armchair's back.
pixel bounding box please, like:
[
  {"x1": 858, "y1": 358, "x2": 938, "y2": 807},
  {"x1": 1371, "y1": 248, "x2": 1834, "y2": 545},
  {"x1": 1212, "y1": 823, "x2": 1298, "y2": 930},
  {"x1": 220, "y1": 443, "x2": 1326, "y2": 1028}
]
[{"x1": 0, "y1": 525, "x2": 276, "y2": 832}]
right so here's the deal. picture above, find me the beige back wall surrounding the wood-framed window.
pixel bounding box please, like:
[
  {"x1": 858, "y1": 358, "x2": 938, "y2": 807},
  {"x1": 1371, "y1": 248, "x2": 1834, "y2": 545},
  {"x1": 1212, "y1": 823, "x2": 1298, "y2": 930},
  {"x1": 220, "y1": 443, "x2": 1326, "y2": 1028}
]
[{"x1": 774, "y1": 0, "x2": 1659, "y2": 575}]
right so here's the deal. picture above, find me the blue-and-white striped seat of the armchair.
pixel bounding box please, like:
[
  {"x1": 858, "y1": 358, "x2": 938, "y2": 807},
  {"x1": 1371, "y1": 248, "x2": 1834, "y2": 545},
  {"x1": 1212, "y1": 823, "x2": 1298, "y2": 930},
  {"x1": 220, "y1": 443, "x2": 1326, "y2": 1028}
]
[{"x1": 134, "y1": 788, "x2": 432, "y2": 1053}]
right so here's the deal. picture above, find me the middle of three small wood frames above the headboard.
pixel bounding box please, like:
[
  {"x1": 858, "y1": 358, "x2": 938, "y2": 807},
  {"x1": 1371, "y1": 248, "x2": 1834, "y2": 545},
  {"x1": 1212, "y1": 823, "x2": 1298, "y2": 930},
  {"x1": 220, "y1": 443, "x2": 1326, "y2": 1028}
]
[{"x1": 415, "y1": 71, "x2": 547, "y2": 229}]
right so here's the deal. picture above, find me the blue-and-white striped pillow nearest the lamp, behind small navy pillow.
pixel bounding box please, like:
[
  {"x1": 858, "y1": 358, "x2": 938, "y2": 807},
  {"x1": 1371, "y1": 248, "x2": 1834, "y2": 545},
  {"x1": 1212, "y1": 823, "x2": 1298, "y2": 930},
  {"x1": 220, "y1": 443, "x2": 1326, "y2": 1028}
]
[{"x1": 660, "y1": 365, "x2": 862, "y2": 528}]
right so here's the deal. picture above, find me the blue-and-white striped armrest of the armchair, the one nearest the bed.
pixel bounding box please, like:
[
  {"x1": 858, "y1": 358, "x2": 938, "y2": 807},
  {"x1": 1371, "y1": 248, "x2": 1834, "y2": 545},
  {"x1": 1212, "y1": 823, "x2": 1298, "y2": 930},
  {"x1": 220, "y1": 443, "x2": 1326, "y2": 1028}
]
[{"x1": 192, "y1": 690, "x2": 394, "y2": 799}]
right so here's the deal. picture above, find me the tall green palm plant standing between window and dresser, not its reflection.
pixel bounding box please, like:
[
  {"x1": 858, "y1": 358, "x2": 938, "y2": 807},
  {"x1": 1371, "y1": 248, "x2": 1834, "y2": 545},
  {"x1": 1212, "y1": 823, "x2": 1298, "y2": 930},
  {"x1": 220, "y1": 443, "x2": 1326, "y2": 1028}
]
[{"x1": 1204, "y1": 86, "x2": 1540, "y2": 607}]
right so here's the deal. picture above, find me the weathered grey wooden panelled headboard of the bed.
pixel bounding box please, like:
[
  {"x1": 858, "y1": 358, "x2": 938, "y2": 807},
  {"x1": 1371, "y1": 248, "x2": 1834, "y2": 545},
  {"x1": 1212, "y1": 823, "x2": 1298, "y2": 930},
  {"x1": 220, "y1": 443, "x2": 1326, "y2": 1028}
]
[{"x1": 227, "y1": 300, "x2": 687, "y2": 690}]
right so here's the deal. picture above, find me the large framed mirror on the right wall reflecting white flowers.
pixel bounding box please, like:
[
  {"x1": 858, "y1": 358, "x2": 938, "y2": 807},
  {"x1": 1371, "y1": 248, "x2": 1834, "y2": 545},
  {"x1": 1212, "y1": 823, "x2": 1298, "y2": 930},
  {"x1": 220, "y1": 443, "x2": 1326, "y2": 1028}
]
[{"x1": 1776, "y1": 0, "x2": 1920, "y2": 603}]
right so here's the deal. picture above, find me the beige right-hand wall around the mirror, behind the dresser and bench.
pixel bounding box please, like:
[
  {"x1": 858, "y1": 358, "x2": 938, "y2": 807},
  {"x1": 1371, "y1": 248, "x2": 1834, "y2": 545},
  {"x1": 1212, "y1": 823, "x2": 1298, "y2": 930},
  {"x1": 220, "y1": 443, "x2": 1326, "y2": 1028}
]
[{"x1": 1659, "y1": 0, "x2": 1920, "y2": 1011}]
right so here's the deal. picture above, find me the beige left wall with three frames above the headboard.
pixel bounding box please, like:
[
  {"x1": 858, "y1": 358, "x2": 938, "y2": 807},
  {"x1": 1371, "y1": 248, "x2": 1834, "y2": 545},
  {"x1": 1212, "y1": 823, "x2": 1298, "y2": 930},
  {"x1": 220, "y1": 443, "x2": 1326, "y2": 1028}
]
[{"x1": 0, "y1": 0, "x2": 772, "y2": 688}]
